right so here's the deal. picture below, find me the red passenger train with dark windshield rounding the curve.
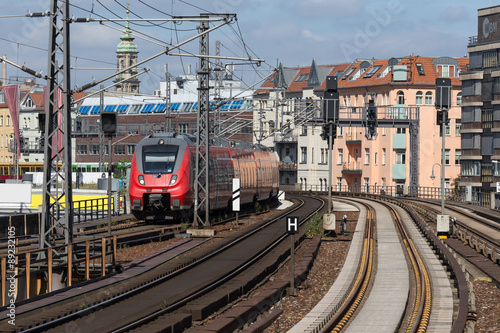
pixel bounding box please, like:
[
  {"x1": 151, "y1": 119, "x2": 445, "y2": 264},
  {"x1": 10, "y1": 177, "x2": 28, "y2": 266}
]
[{"x1": 129, "y1": 133, "x2": 279, "y2": 220}]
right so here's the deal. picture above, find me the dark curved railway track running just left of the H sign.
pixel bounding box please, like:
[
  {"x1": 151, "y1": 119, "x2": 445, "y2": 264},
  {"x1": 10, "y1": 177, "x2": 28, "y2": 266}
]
[{"x1": 0, "y1": 193, "x2": 323, "y2": 332}]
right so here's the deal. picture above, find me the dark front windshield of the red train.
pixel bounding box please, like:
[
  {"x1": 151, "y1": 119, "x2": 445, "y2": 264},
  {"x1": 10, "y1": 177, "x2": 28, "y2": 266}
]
[{"x1": 142, "y1": 145, "x2": 179, "y2": 174}]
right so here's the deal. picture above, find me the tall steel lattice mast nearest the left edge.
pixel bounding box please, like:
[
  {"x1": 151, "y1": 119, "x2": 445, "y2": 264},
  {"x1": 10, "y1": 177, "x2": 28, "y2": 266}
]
[{"x1": 39, "y1": 0, "x2": 73, "y2": 248}]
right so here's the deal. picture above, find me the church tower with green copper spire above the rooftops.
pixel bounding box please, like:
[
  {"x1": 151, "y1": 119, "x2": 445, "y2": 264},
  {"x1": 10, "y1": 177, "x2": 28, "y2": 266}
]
[{"x1": 115, "y1": 3, "x2": 139, "y2": 94}]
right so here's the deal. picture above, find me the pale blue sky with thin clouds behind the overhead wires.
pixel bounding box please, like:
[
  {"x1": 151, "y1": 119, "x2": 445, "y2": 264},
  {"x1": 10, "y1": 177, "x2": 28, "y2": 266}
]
[{"x1": 0, "y1": 0, "x2": 494, "y2": 93}]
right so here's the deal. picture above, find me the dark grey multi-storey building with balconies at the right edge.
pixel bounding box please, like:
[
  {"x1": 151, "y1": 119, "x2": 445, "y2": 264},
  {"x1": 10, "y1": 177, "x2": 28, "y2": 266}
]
[{"x1": 460, "y1": 6, "x2": 500, "y2": 199}]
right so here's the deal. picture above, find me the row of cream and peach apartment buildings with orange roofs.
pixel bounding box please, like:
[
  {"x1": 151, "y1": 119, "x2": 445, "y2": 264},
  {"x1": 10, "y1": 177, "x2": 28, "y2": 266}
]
[{"x1": 254, "y1": 56, "x2": 468, "y2": 193}]
